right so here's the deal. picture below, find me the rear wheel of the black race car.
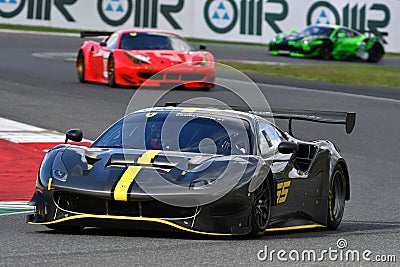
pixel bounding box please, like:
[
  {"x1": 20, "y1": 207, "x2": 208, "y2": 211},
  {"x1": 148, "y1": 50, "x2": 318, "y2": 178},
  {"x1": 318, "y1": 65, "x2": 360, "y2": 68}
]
[{"x1": 327, "y1": 166, "x2": 346, "y2": 230}]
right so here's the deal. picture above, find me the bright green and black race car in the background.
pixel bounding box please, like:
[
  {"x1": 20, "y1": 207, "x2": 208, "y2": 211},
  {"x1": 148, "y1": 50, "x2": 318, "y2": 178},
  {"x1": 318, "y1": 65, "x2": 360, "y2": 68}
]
[{"x1": 269, "y1": 25, "x2": 387, "y2": 62}]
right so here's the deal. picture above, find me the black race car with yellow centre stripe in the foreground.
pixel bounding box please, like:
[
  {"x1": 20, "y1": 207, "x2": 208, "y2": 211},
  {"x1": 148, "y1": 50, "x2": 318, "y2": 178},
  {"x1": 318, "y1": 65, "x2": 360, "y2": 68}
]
[{"x1": 28, "y1": 104, "x2": 355, "y2": 236}]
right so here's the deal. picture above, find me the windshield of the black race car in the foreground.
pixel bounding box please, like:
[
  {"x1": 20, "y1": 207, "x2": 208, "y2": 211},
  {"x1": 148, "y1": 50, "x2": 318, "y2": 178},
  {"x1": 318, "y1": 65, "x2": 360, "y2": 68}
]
[{"x1": 93, "y1": 112, "x2": 252, "y2": 155}]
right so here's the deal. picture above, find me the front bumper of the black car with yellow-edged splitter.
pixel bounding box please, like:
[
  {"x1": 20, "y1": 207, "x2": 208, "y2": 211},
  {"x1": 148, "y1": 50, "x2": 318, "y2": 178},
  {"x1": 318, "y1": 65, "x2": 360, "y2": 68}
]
[{"x1": 28, "y1": 182, "x2": 253, "y2": 235}]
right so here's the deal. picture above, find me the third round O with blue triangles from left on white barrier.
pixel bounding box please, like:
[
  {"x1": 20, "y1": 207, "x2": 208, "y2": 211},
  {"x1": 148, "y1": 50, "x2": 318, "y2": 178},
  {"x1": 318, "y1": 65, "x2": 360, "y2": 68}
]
[{"x1": 204, "y1": 0, "x2": 238, "y2": 33}]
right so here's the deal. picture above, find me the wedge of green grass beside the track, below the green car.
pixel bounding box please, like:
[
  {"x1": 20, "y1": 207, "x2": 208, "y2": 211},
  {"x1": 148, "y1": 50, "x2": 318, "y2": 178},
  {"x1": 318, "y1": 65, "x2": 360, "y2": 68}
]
[{"x1": 222, "y1": 62, "x2": 400, "y2": 87}]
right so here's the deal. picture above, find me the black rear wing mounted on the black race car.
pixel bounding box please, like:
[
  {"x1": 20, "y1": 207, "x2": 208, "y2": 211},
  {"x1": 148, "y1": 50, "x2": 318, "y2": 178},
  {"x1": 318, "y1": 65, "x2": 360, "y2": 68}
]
[{"x1": 165, "y1": 102, "x2": 356, "y2": 135}]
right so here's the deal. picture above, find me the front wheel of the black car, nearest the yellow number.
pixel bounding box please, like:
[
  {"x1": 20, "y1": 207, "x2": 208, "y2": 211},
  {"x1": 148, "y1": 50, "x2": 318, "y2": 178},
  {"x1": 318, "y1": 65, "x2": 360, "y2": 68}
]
[{"x1": 250, "y1": 180, "x2": 271, "y2": 237}]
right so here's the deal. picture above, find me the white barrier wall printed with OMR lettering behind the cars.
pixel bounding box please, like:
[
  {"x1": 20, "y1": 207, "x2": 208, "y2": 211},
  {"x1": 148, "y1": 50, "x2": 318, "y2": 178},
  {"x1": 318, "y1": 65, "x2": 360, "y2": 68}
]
[{"x1": 0, "y1": 0, "x2": 400, "y2": 52}]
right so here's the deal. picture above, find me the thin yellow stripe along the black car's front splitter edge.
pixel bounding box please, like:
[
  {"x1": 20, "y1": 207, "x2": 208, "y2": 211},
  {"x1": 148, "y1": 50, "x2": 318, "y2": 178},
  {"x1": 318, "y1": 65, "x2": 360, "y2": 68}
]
[{"x1": 29, "y1": 214, "x2": 231, "y2": 236}]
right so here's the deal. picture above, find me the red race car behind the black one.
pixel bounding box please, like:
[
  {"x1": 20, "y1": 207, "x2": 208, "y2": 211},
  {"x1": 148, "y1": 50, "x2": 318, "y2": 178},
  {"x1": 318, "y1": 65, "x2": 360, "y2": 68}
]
[{"x1": 76, "y1": 29, "x2": 215, "y2": 90}]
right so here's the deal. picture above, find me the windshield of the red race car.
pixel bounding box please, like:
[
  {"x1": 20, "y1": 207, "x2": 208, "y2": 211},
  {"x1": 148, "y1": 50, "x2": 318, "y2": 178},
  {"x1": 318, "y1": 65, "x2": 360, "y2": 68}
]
[{"x1": 120, "y1": 32, "x2": 193, "y2": 51}]
